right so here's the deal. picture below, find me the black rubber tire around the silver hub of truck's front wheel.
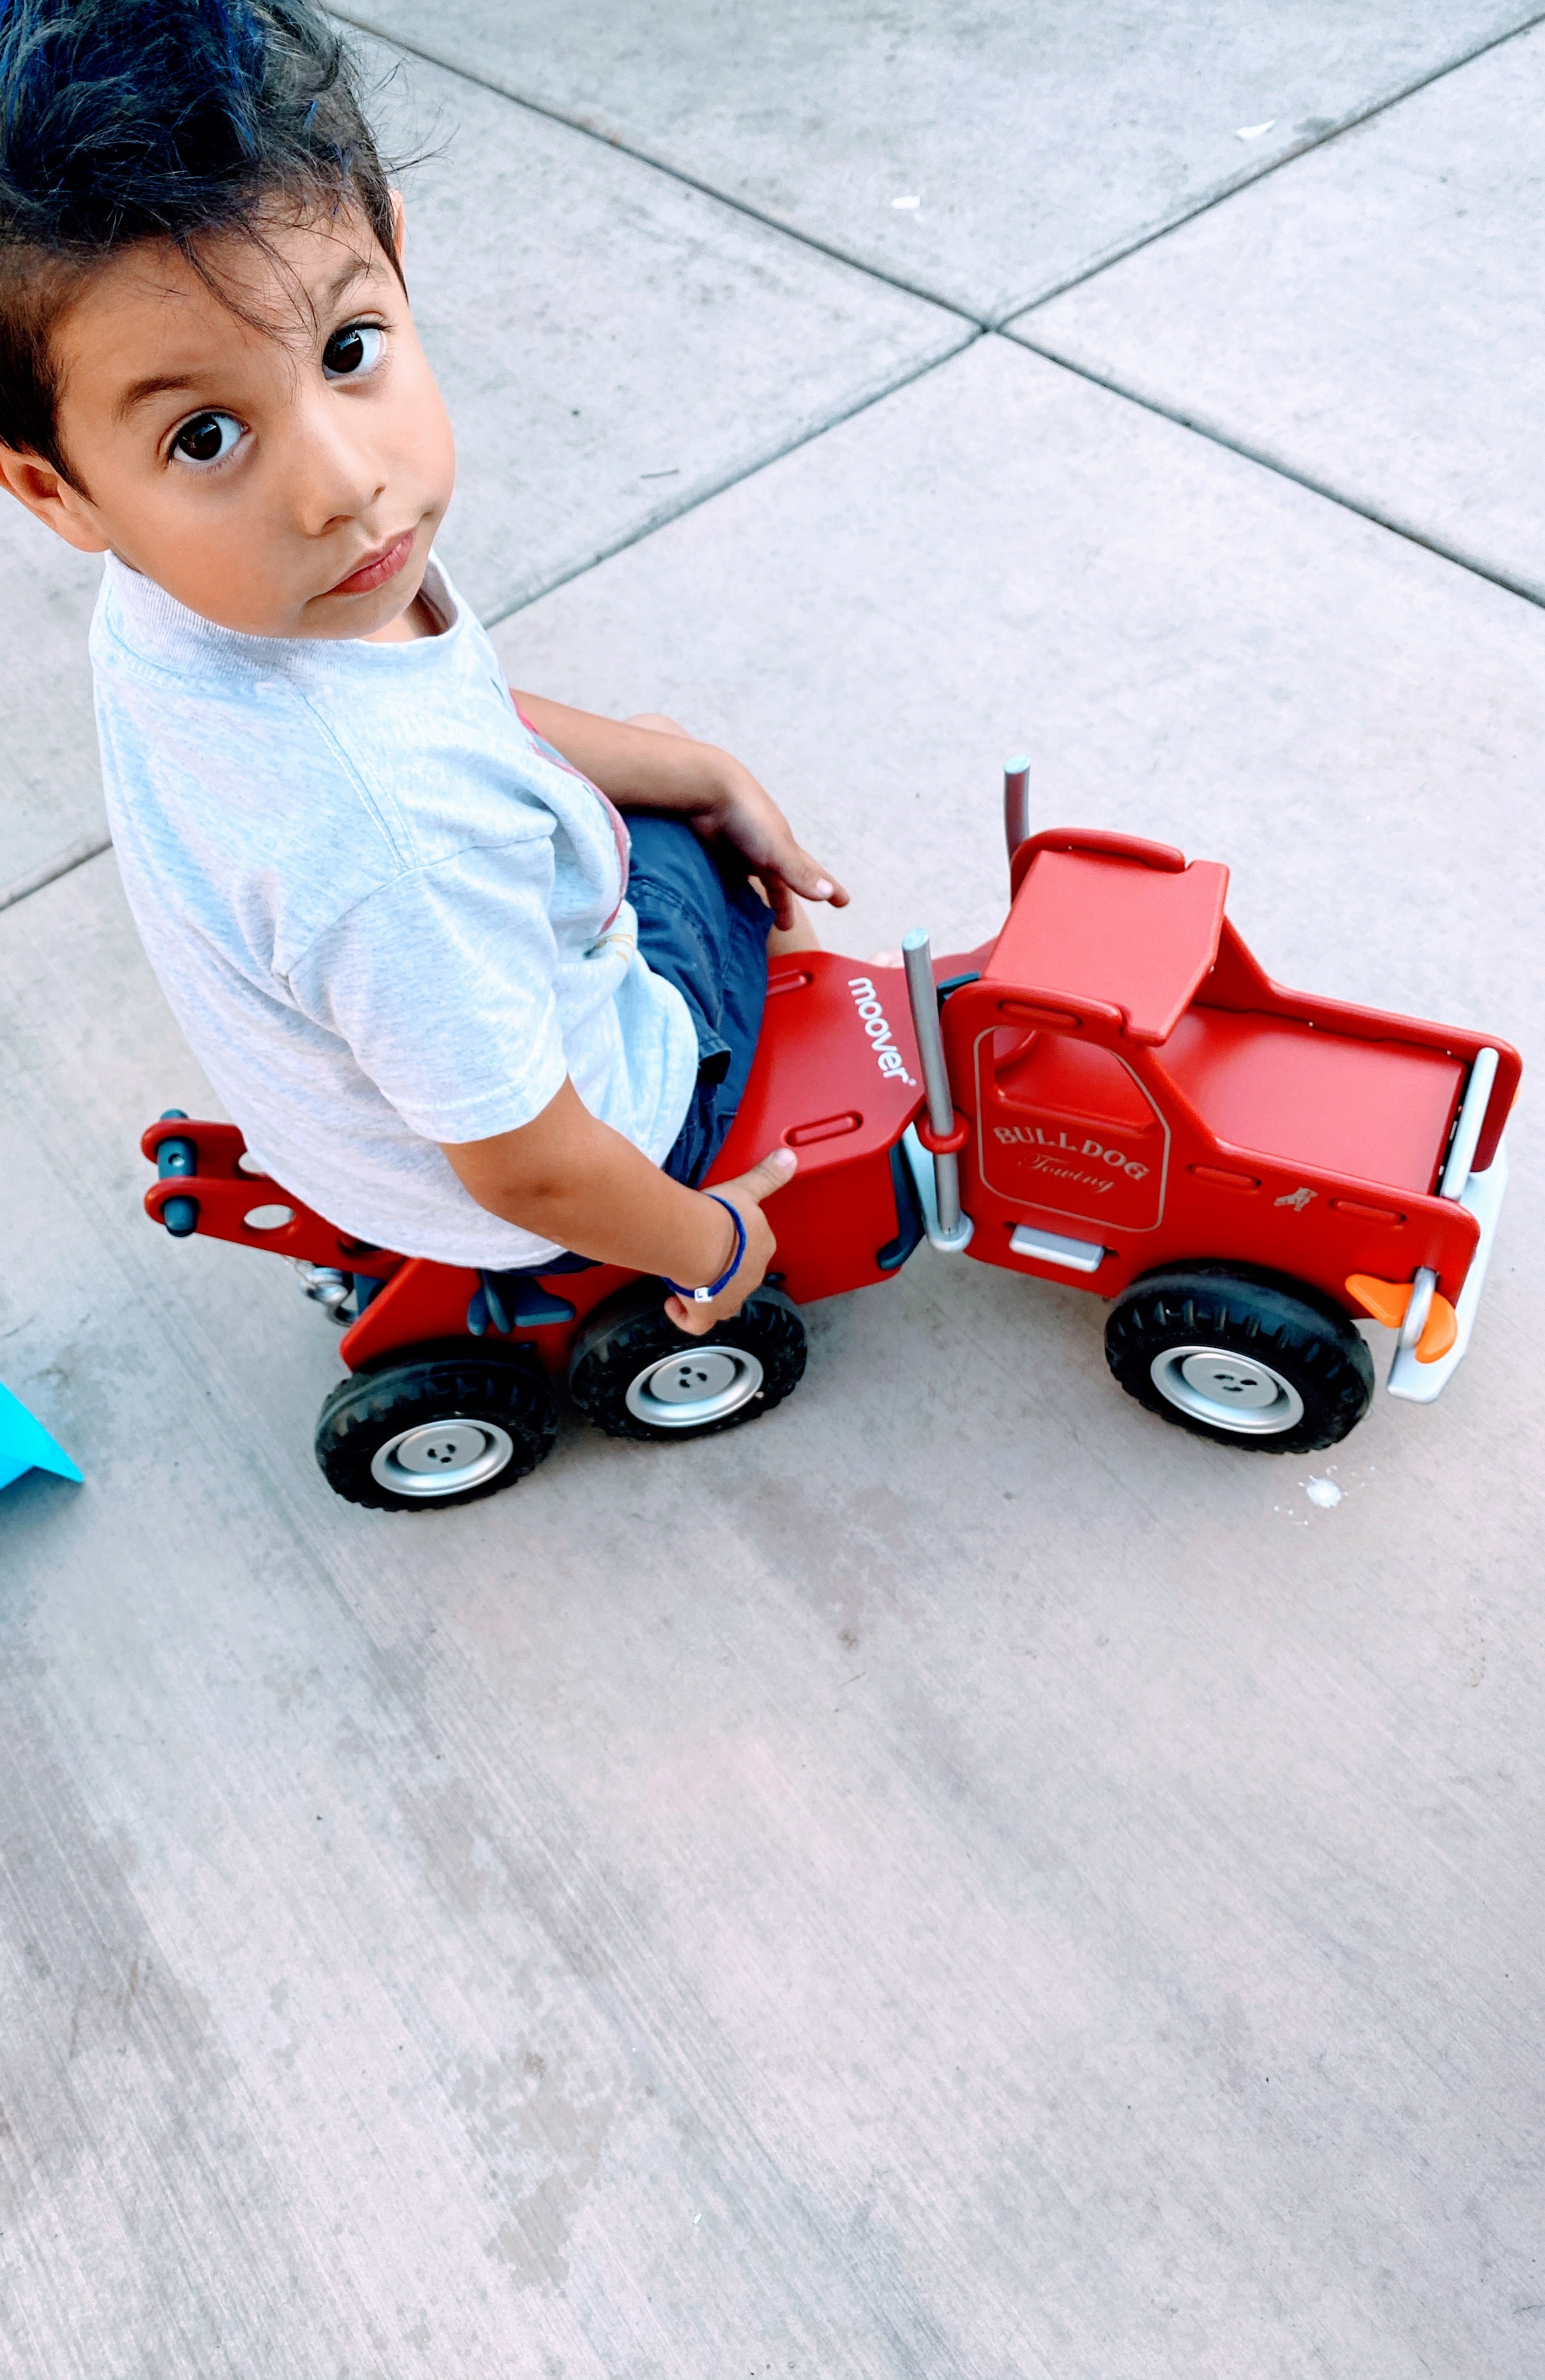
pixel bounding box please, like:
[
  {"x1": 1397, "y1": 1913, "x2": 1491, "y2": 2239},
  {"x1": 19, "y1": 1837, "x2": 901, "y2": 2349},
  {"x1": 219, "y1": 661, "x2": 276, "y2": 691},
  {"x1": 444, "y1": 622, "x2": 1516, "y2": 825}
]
[{"x1": 1105, "y1": 1264, "x2": 1374, "y2": 1454}]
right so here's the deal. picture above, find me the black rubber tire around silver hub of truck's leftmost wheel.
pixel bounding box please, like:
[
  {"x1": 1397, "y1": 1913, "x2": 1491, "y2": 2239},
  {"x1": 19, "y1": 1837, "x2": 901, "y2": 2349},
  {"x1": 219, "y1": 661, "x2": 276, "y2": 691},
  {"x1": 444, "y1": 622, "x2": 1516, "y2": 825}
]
[{"x1": 316, "y1": 1340, "x2": 557, "y2": 1511}]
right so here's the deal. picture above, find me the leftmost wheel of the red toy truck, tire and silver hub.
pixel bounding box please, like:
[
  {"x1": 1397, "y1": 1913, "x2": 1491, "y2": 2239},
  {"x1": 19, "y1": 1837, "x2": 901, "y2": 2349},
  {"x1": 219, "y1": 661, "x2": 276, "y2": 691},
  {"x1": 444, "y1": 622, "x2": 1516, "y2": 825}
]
[{"x1": 316, "y1": 1345, "x2": 557, "y2": 1511}]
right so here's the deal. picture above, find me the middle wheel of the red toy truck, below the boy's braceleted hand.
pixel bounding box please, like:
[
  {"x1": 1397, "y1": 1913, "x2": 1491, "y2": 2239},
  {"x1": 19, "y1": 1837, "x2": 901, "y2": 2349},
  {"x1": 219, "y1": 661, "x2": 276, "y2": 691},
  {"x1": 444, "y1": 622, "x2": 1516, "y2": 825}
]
[{"x1": 569, "y1": 1280, "x2": 805, "y2": 1440}]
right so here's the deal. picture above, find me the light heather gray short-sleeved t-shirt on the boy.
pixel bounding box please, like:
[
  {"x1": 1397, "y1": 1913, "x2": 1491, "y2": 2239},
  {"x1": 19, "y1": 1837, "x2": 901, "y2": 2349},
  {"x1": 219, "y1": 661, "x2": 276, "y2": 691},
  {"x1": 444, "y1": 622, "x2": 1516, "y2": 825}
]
[{"x1": 90, "y1": 557, "x2": 697, "y2": 1269}]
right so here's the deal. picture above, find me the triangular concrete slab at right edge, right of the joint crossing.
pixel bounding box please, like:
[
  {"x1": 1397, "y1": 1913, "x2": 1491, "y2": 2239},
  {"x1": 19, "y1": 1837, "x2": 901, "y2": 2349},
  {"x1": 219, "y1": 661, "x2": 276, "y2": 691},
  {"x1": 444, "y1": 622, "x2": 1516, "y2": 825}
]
[{"x1": 1012, "y1": 31, "x2": 1545, "y2": 600}]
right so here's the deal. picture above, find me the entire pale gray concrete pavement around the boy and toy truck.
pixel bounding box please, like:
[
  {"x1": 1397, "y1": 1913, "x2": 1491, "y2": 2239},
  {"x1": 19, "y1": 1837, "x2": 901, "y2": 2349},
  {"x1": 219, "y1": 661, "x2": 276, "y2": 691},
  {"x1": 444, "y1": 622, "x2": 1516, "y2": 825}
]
[{"x1": 0, "y1": 0, "x2": 1545, "y2": 2380}]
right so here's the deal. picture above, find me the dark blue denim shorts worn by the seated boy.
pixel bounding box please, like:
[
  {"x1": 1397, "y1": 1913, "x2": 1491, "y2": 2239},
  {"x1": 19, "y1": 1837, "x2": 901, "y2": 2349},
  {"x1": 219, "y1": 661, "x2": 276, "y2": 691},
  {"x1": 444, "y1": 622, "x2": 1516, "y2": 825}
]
[{"x1": 623, "y1": 809, "x2": 771, "y2": 1185}]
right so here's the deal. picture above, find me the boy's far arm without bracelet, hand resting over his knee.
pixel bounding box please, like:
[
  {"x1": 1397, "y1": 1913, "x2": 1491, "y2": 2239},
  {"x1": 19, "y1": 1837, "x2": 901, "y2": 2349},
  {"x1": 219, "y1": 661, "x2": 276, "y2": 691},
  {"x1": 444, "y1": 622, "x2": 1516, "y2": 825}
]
[{"x1": 517, "y1": 695, "x2": 848, "y2": 928}]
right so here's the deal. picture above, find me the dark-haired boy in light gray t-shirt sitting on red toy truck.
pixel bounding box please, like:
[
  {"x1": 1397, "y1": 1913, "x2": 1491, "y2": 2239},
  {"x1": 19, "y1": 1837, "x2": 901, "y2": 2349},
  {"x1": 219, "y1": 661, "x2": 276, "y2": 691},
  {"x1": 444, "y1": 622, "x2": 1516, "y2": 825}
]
[{"x1": 0, "y1": 0, "x2": 848, "y2": 1333}]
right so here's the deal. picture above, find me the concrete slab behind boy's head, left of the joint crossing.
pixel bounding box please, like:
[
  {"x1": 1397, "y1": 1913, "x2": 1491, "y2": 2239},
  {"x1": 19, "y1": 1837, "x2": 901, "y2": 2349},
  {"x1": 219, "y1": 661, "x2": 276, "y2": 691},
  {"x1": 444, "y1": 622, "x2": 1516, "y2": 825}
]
[{"x1": 0, "y1": 45, "x2": 969, "y2": 902}]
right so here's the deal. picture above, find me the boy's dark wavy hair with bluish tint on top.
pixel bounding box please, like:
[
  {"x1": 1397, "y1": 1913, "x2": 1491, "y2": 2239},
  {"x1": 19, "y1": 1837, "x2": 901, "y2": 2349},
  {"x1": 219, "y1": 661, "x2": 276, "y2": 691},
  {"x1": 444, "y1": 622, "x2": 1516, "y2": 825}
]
[{"x1": 0, "y1": 0, "x2": 393, "y2": 478}]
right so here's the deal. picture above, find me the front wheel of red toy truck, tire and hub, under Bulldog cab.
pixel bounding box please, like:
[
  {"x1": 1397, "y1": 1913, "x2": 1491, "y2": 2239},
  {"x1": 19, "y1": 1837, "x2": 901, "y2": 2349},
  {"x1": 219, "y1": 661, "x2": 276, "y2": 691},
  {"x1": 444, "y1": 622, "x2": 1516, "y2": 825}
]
[{"x1": 1105, "y1": 1264, "x2": 1374, "y2": 1454}]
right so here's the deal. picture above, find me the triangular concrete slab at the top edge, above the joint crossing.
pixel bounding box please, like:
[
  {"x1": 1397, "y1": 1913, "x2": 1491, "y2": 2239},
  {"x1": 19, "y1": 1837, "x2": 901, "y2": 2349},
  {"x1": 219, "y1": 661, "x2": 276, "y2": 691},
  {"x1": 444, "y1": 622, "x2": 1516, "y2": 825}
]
[{"x1": 345, "y1": 0, "x2": 1536, "y2": 319}]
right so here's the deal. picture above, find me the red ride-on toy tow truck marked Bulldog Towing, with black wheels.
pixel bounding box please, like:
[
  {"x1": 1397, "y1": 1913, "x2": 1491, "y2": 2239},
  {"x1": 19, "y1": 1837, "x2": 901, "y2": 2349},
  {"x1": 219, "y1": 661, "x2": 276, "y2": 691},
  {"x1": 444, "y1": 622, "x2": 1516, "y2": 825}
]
[{"x1": 143, "y1": 761, "x2": 1519, "y2": 1511}]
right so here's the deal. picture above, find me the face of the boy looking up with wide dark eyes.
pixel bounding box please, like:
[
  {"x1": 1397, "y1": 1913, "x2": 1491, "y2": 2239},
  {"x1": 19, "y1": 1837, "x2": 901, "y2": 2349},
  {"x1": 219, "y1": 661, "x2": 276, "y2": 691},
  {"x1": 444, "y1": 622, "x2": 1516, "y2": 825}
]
[{"x1": 0, "y1": 198, "x2": 455, "y2": 638}]
